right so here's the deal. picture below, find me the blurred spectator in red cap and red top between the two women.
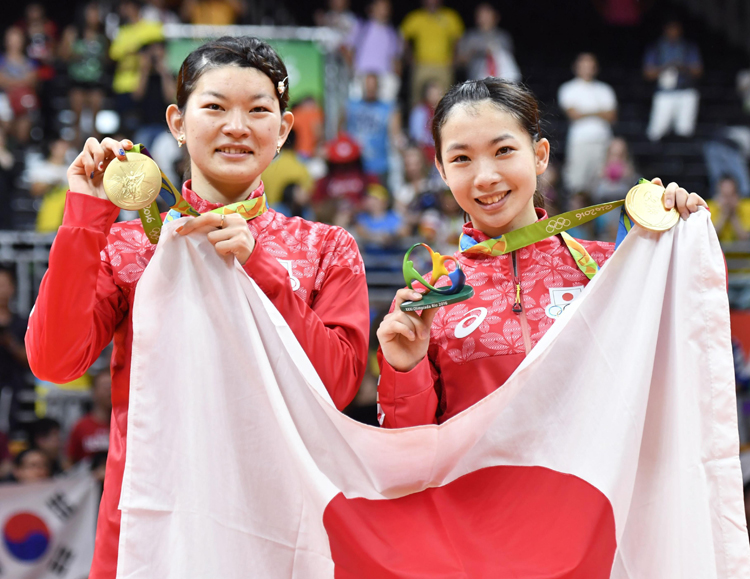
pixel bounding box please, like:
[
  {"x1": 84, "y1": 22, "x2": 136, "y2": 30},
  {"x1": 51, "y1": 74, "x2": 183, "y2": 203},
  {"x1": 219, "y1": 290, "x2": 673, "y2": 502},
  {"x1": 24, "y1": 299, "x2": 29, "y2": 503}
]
[{"x1": 312, "y1": 133, "x2": 378, "y2": 227}]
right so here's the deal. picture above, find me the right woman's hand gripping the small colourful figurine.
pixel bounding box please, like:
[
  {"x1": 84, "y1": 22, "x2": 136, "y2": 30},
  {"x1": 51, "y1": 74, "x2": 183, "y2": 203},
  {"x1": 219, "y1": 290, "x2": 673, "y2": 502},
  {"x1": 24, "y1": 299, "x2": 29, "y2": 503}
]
[{"x1": 378, "y1": 287, "x2": 438, "y2": 372}]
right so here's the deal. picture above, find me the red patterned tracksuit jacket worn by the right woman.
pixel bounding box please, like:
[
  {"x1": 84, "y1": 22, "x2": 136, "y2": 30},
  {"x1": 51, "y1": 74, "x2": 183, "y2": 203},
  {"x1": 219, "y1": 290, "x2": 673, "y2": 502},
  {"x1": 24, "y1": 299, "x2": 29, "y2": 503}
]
[{"x1": 378, "y1": 209, "x2": 614, "y2": 428}]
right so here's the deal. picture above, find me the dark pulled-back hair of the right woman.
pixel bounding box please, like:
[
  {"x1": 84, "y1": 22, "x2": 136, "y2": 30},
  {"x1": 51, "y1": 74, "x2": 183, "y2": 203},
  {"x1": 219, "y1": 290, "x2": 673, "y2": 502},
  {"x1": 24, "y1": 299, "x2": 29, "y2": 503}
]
[{"x1": 432, "y1": 77, "x2": 544, "y2": 207}]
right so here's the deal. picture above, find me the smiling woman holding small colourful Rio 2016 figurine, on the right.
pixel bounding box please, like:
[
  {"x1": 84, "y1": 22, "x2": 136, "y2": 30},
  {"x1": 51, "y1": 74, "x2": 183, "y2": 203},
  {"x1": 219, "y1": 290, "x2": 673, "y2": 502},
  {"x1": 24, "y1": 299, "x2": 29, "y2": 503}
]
[{"x1": 377, "y1": 78, "x2": 706, "y2": 428}]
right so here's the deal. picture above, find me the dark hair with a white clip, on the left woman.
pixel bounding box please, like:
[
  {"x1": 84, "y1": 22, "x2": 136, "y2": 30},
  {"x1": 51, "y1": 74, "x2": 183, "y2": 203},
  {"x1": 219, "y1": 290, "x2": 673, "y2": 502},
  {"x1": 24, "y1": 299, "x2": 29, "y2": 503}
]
[{"x1": 177, "y1": 36, "x2": 289, "y2": 113}]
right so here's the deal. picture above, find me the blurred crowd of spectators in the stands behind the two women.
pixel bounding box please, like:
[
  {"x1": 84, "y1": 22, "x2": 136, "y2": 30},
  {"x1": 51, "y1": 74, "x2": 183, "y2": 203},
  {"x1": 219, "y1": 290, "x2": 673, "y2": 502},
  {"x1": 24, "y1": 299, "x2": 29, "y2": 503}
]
[{"x1": 0, "y1": 0, "x2": 750, "y2": 536}]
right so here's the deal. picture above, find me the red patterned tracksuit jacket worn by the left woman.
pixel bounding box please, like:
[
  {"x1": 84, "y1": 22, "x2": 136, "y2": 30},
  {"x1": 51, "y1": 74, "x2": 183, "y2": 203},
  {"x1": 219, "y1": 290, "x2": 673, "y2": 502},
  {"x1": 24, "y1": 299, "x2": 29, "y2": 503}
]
[{"x1": 26, "y1": 181, "x2": 369, "y2": 579}]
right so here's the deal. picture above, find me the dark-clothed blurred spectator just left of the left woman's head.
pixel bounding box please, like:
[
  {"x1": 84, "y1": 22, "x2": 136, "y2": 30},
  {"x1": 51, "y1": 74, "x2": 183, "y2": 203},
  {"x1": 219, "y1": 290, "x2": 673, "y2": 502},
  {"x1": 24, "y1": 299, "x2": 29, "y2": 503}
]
[{"x1": 133, "y1": 42, "x2": 177, "y2": 148}]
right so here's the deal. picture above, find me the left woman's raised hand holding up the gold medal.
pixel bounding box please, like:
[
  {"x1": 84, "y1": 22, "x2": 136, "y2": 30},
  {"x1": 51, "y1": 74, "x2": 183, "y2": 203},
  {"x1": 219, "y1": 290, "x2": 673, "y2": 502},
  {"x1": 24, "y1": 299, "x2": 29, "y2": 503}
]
[{"x1": 68, "y1": 137, "x2": 133, "y2": 199}]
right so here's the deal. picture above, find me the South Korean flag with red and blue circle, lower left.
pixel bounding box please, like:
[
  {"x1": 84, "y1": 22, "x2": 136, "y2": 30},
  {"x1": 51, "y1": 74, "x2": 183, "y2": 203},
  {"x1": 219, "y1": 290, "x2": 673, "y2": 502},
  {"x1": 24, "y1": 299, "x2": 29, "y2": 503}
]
[{"x1": 0, "y1": 464, "x2": 100, "y2": 579}]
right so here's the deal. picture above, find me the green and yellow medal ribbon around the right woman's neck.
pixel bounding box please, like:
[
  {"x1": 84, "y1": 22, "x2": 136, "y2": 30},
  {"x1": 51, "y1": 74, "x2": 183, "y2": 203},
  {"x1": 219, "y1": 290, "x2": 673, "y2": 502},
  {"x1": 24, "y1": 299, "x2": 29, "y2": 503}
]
[{"x1": 458, "y1": 199, "x2": 632, "y2": 279}]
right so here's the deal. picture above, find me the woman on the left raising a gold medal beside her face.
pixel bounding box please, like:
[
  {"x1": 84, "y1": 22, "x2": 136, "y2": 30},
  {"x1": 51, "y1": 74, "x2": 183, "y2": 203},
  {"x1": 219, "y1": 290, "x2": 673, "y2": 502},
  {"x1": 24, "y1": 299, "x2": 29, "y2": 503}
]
[{"x1": 26, "y1": 37, "x2": 369, "y2": 579}]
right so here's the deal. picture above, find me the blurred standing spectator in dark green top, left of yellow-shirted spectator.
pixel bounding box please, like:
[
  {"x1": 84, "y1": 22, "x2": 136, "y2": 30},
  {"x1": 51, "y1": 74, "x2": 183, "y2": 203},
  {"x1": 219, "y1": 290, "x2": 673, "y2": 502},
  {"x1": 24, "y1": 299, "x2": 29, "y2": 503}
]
[{"x1": 60, "y1": 2, "x2": 109, "y2": 143}]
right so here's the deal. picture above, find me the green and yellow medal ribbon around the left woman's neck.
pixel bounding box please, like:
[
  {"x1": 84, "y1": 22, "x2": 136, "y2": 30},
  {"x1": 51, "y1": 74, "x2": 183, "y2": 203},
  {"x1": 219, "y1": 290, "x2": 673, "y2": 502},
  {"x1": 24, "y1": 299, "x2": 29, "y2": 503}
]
[{"x1": 128, "y1": 144, "x2": 268, "y2": 244}]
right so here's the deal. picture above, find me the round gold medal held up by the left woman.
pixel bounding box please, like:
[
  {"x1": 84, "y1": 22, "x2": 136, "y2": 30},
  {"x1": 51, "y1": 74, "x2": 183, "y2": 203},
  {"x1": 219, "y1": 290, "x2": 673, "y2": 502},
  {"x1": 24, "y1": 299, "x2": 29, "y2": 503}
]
[{"x1": 104, "y1": 153, "x2": 161, "y2": 211}]
